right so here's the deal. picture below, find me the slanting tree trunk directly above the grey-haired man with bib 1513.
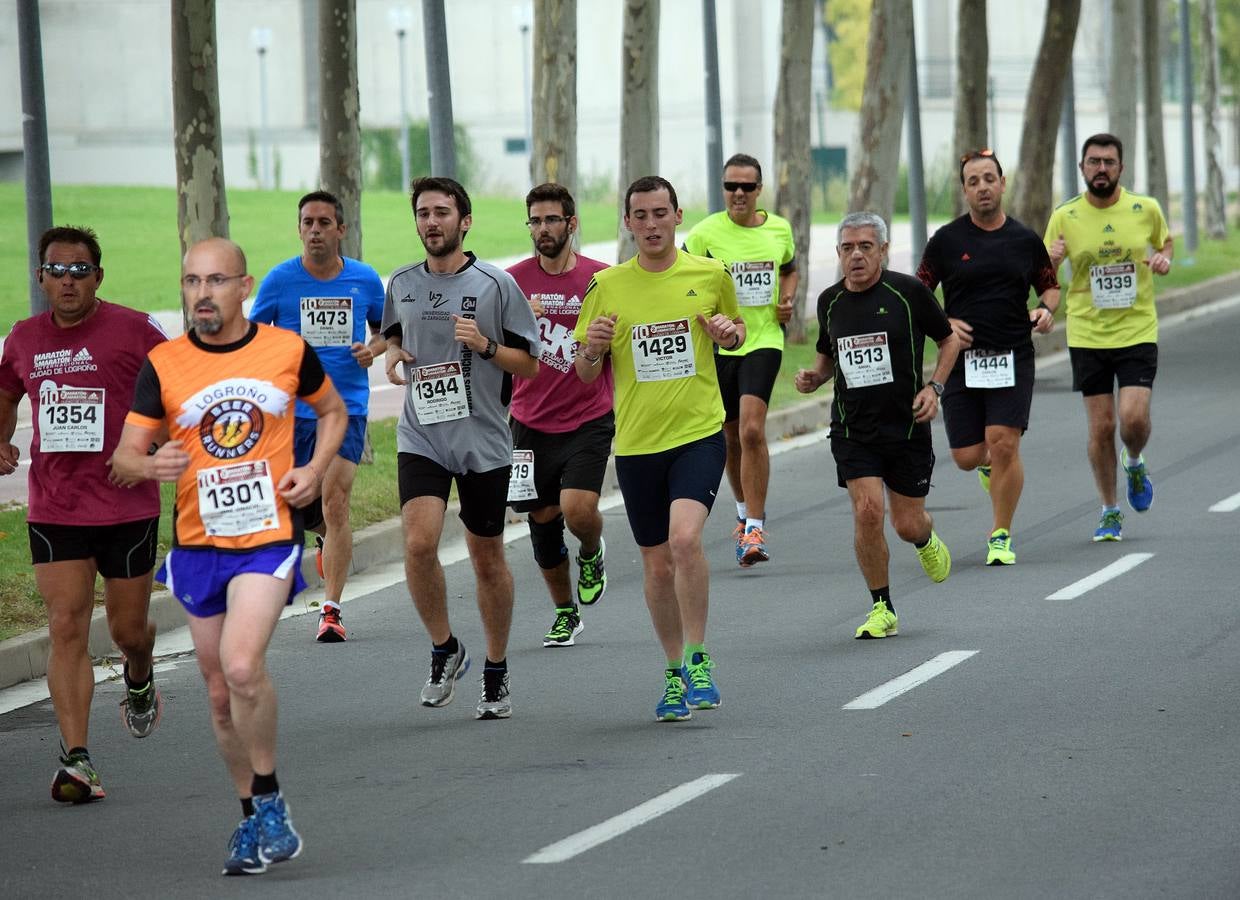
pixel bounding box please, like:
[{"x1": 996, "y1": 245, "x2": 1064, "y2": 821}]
[{"x1": 848, "y1": 0, "x2": 913, "y2": 234}]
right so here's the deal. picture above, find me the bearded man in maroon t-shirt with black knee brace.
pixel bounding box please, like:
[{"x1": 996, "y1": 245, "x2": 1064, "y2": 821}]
[{"x1": 508, "y1": 183, "x2": 615, "y2": 647}]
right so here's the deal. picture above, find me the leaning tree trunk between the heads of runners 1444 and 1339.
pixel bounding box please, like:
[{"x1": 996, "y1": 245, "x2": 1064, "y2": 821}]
[{"x1": 1012, "y1": 0, "x2": 1081, "y2": 234}]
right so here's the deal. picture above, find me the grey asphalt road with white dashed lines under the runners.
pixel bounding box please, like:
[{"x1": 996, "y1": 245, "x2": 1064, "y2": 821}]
[{"x1": 7, "y1": 305, "x2": 1240, "y2": 900}]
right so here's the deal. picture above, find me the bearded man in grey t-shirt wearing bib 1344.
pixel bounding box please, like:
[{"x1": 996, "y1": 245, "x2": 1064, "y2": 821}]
[{"x1": 382, "y1": 177, "x2": 541, "y2": 719}]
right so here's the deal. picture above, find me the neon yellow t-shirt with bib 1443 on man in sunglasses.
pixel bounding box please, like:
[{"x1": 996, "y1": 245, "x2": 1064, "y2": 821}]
[{"x1": 684, "y1": 210, "x2": 796, "y2": 356}]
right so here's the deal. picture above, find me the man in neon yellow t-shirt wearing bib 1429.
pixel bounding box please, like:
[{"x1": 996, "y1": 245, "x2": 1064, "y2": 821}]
[{"x1": 573, "y1": 175, "x2": 745, "y2": 721}]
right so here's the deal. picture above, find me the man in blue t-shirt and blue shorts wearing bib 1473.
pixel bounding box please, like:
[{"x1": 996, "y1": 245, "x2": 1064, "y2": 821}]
[{"x1": 249, "y1": 191, "x2": 387, "y2": 643}]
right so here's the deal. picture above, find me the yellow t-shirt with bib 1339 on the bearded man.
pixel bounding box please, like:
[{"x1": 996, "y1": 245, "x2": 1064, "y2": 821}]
[{"x1": 1043, "y1": 187, "x2": 1171, "y2": 350}]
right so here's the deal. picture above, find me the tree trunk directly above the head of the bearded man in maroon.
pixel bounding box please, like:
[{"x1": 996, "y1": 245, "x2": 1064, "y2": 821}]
[{"x1": 529, "y1": 0, "x2": 577, "y2": 196}]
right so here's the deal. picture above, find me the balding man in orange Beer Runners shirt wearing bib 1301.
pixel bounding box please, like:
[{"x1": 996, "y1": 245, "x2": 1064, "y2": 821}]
[{"x1": 114, "y1": 238, "x2": 347, "y2": 875}]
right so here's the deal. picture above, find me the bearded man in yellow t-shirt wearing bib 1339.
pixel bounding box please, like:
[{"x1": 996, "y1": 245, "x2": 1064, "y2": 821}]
[{"x1": 1043, "y1": 134, "x2": 1172, "y2": 540}]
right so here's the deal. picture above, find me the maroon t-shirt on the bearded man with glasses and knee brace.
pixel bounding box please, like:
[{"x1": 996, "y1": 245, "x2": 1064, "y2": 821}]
[{"x1": 508, "y1": 254, "x2": 615, "y2": 434}]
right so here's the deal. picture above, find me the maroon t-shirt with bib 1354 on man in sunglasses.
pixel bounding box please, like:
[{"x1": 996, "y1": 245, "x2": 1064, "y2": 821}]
[{"x1": 0, "y1": 300, "x2": 167, "y2": 526}]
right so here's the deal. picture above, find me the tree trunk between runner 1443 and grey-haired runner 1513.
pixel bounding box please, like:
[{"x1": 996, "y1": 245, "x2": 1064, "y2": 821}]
[{"x1": 775, "y1": 0, "x2": 815, "y2": 343}]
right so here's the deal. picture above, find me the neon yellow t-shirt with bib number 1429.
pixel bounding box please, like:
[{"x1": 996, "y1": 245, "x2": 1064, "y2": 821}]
[{"x1": 573, "y1": 250, "x2": 739, "y2": 456}]
